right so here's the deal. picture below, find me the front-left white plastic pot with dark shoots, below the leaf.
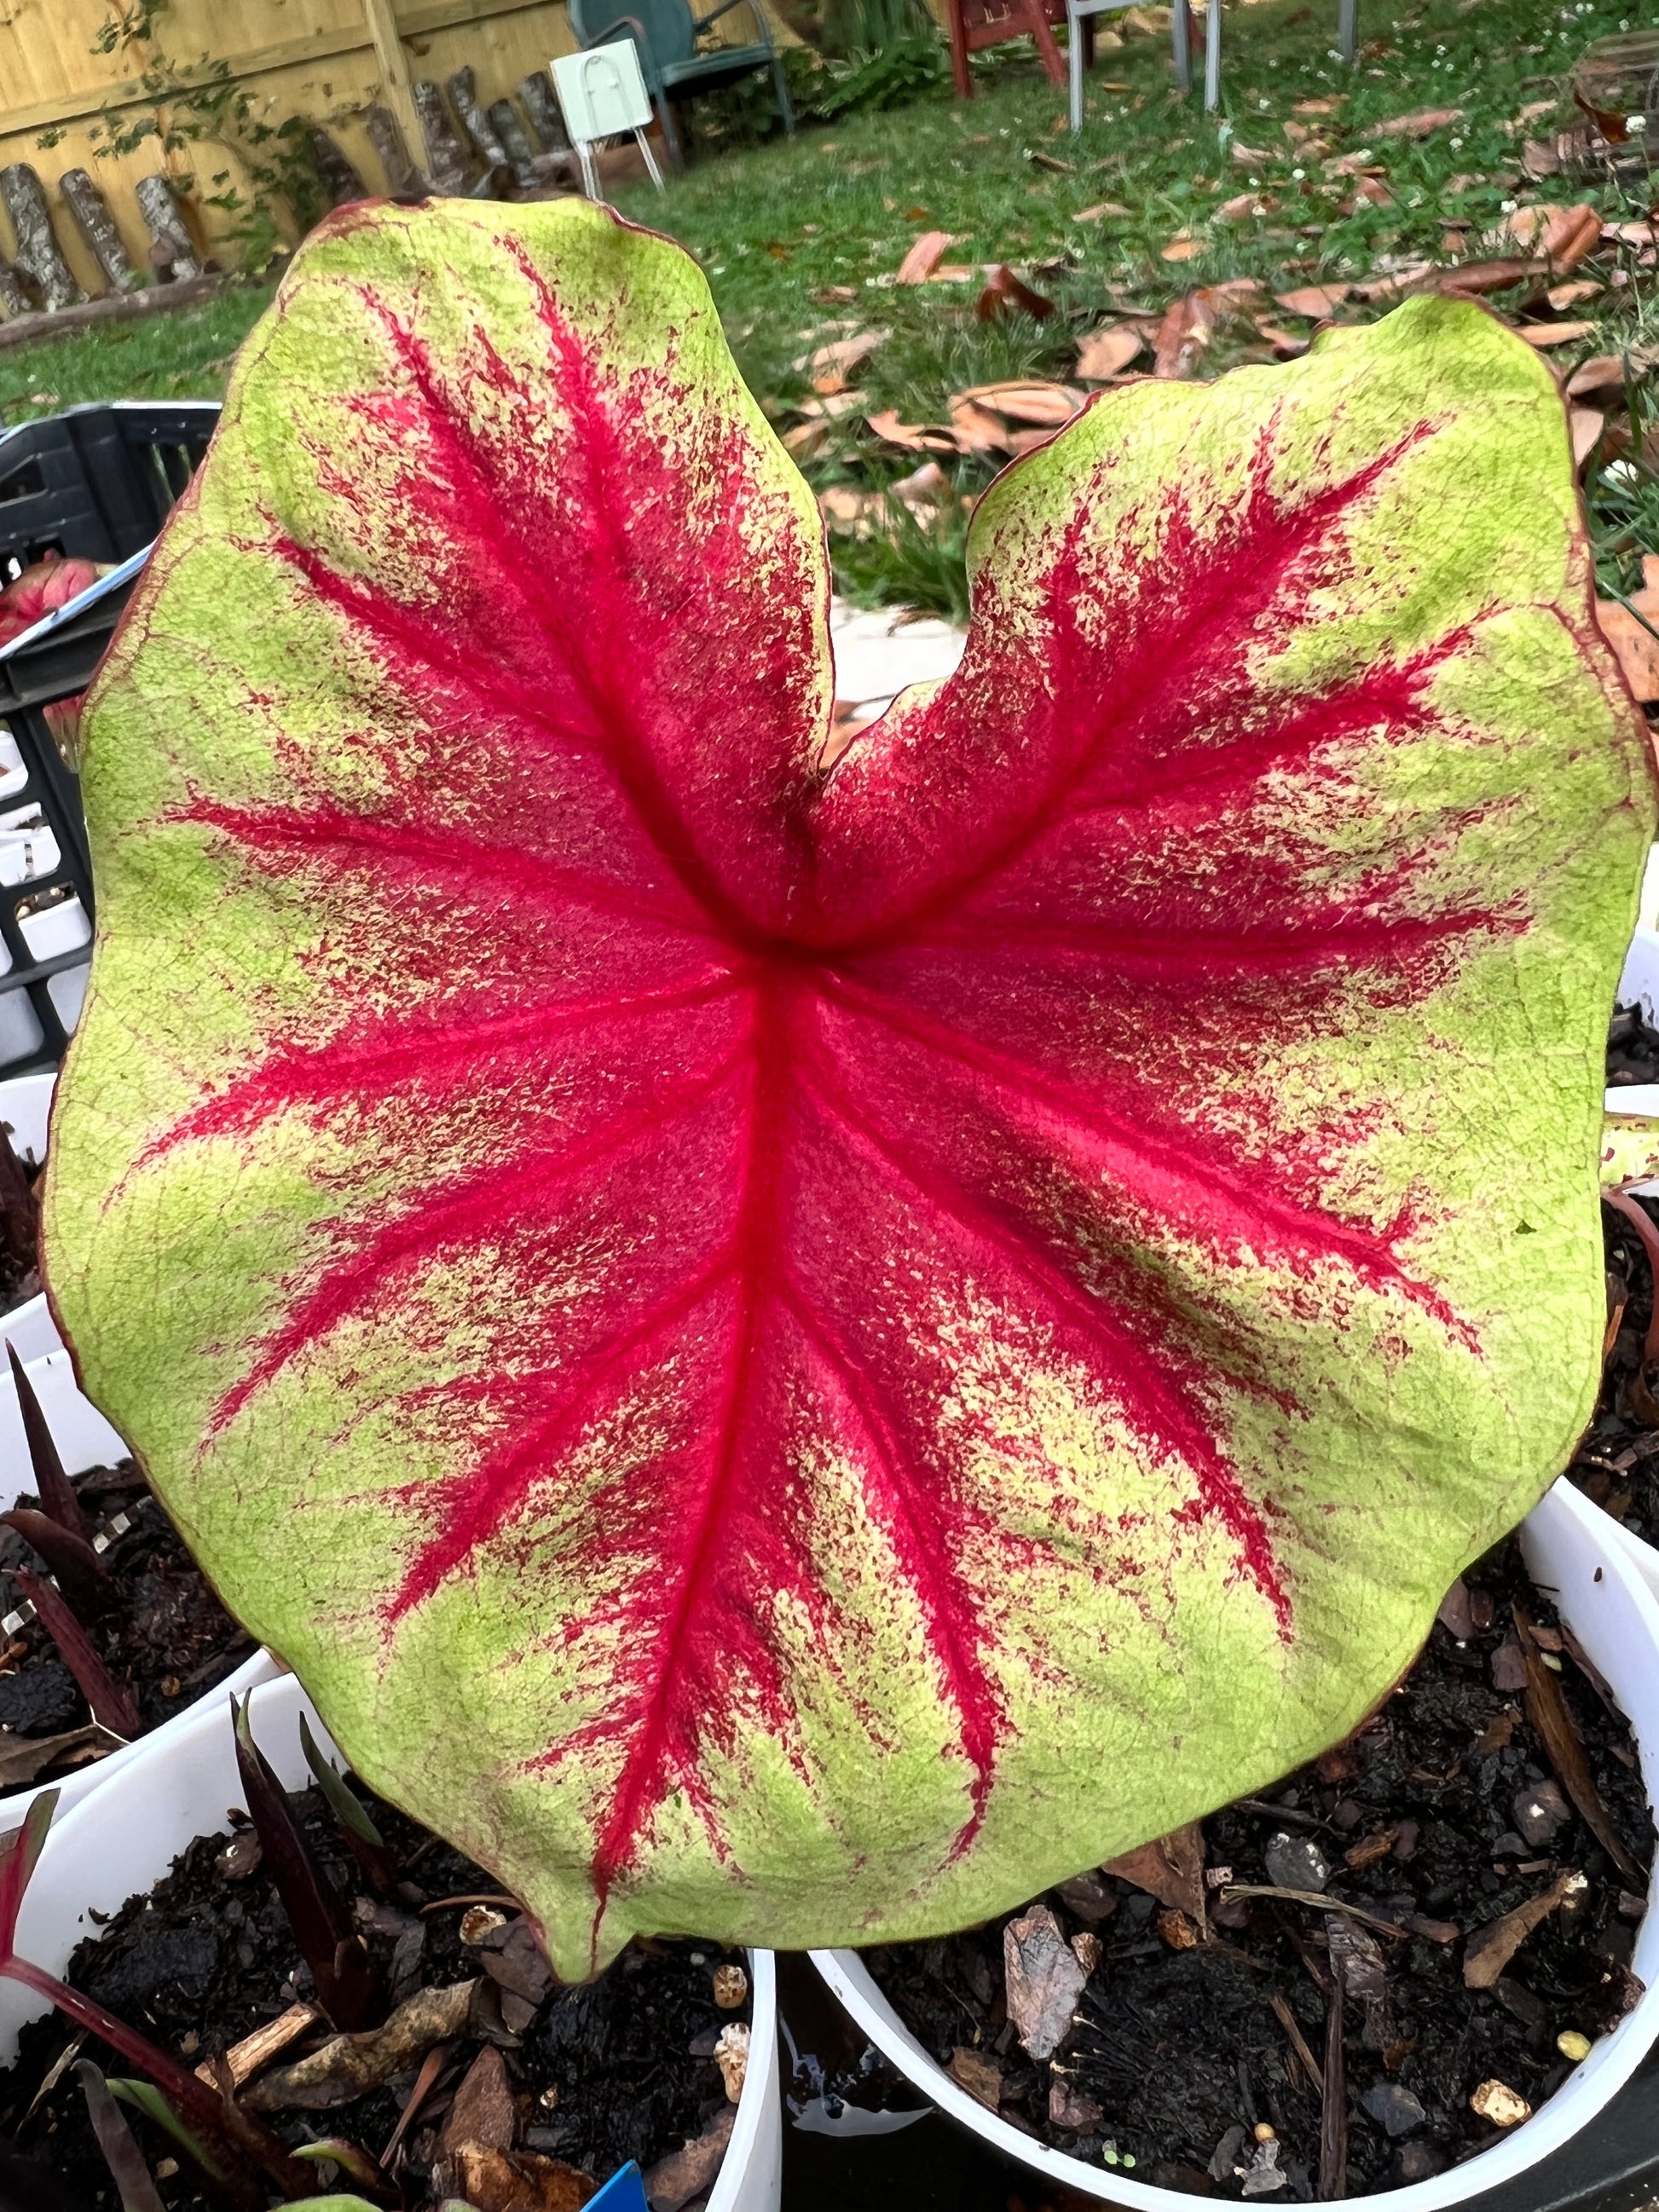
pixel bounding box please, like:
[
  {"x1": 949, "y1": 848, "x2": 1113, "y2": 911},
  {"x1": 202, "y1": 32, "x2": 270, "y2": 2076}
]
[{"x1": 0, "y1": 1674, "x2": 783, "y2": 2212}]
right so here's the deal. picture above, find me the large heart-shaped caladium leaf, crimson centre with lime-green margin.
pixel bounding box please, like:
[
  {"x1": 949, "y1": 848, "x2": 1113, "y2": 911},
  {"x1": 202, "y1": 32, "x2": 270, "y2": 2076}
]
[{"x1": 46, "y1": 201, "x2": 1655, "y2": 1975}]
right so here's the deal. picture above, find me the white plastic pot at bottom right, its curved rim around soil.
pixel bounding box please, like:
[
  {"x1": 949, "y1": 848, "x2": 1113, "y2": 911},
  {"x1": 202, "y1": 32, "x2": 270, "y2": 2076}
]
[{"x1": 812, "y1": 1482, "x2": 1659, "y2": 2212}]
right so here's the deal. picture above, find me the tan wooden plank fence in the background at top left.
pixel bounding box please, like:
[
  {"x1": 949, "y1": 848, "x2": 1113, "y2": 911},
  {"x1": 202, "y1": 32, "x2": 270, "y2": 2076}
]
[{"x1": 0, "y1": 0, "x2": 610, "y2": 292}]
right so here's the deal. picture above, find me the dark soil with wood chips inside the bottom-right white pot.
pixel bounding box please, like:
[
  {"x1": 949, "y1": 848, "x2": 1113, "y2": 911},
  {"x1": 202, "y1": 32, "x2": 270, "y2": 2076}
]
[{"x1": 858, "y1": 1539, "x2": 1652, "y2": 2201}]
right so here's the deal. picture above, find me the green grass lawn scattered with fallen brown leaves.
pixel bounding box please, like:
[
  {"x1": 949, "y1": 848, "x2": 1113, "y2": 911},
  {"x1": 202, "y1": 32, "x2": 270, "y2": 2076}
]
[{"x1": 0, "y1": 0, "x2": 1659, "y2": 610}]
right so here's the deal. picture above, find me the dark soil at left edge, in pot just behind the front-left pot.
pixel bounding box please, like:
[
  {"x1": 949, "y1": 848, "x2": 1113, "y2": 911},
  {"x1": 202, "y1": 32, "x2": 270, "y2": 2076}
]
[{"x1": 0, "y1": 1460, "x2": 252, "y2": 1778}]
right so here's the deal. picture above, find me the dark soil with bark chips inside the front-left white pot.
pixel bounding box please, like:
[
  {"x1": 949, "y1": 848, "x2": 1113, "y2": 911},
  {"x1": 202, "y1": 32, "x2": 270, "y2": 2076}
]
[{"x1": 0, "y1": 1785, "x2": 750, "y2": 2212}]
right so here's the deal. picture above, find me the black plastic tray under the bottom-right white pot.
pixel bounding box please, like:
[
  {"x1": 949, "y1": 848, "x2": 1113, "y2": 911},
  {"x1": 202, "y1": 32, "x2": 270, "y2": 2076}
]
[{"x1": 778, "y1": 1955, "x2": 1659, "y2": 2212}]
